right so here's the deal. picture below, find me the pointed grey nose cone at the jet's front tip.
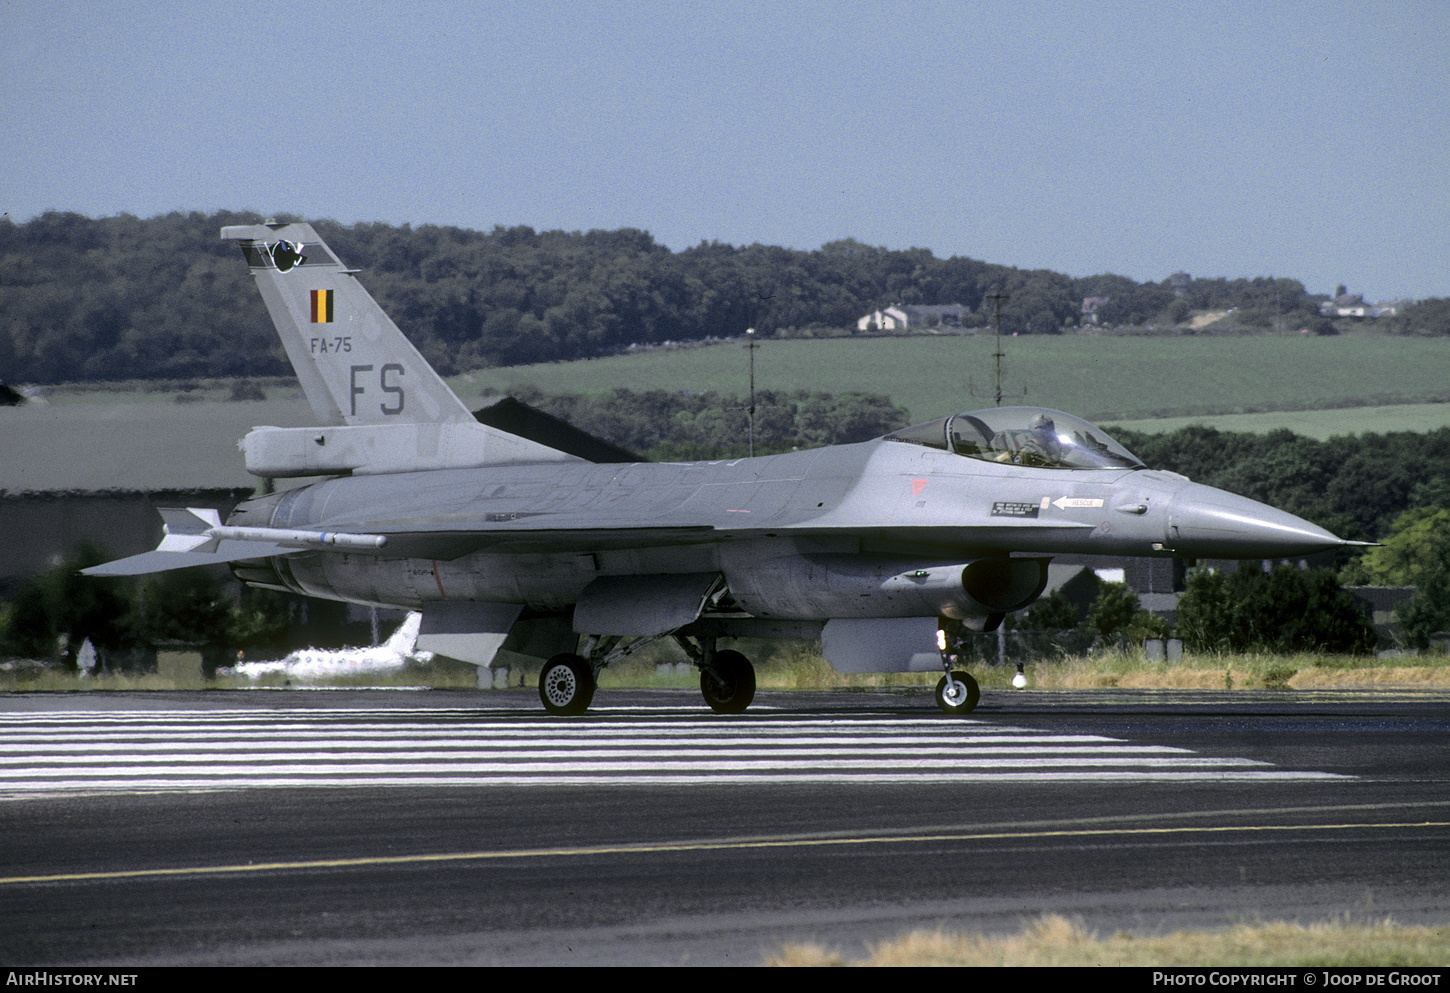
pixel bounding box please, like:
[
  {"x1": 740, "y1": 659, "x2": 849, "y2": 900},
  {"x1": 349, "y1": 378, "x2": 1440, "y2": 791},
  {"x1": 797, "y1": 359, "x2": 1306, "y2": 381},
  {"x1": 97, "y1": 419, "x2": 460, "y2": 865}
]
[{"x1": 1166, "y1": 483, "x2": 1350, "y2": 558}]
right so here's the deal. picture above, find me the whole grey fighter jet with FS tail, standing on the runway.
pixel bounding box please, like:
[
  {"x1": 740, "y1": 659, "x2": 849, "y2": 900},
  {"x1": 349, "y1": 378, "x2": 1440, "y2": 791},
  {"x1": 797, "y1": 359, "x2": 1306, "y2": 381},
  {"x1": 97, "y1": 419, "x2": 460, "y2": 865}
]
[{"x1": 86, "y1": 222, "x2": 1350, "y2": 715}]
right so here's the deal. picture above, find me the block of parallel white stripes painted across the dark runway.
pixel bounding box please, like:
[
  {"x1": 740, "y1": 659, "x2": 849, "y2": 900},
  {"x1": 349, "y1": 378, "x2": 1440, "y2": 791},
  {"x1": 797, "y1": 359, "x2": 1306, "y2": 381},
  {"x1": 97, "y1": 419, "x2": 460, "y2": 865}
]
[{"x1": 0, "y1": 707, "x2": 1327, "y2": 799}]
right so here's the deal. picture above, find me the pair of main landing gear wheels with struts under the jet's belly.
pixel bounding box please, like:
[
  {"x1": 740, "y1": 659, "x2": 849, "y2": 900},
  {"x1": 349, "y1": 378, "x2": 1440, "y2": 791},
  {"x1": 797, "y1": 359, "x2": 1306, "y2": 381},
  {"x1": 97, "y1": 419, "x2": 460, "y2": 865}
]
[{"x1": 539, "y1": 633, "x2": 759, "y2": 718}]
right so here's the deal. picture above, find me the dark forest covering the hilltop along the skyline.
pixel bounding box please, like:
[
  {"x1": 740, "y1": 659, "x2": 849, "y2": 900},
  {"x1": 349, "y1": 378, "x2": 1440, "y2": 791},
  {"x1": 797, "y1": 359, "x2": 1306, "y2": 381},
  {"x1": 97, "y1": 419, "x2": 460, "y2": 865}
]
[{"x1": 14, "y1": 212, "x2": 1450, "y2": 384}]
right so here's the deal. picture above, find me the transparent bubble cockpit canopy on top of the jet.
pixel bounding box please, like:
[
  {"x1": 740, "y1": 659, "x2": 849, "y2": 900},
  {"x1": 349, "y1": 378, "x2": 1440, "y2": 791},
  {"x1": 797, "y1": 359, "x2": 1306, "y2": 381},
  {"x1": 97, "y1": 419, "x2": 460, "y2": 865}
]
[{"x1": 886, "y1": 407, "x2": 1144, "y2": 468}]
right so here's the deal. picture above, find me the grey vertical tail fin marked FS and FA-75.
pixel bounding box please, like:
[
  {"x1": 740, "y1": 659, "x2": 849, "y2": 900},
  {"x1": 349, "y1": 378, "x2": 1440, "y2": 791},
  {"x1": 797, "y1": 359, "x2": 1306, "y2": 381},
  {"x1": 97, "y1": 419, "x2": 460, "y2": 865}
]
[{"x1": 222, "y1": 223, "x2": 473, "y2": 425}]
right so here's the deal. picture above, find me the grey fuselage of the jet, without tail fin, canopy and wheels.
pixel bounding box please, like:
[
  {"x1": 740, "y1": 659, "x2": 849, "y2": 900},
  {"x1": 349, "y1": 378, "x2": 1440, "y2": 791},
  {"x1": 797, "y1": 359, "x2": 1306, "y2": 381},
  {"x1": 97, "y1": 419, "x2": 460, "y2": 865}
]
[{"x1": 228, "y1": 439, "x2": 1340, "y2": 619}]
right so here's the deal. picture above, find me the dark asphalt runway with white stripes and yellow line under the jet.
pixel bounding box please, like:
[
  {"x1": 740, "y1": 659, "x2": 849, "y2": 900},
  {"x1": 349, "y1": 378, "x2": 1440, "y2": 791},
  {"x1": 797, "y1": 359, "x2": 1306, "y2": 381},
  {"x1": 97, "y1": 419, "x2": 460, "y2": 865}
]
[{"x1": 0, "y1": 690, "x2": 1450, "y2": 965}]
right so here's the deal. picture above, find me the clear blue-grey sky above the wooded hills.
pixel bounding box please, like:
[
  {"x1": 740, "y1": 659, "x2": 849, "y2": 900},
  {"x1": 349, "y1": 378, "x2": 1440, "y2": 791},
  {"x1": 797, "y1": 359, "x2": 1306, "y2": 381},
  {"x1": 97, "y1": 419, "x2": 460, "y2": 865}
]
[{"x1": 0, "y1": 0, "x2": 1450, "y2": 300}]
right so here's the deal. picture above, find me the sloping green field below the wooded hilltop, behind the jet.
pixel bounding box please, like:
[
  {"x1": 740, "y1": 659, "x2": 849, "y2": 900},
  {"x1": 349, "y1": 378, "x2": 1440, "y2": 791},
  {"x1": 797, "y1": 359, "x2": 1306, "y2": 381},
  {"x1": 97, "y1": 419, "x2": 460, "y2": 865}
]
[{"x1": 454, "y1": 333, "x2": 1450, "y2": 435}]
